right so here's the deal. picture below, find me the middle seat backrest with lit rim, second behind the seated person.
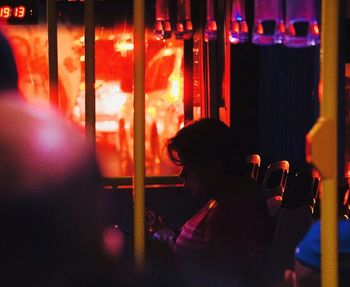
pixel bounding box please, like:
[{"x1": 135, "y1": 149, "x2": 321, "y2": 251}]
[{"x1": 262, "y1": 160, "x2": 289, "y2": 198}]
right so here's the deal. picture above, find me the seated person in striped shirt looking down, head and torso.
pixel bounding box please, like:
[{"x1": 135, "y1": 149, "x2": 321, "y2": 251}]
[{"x1": 167, "y1": 118, "x2": 269, "y2": 287}]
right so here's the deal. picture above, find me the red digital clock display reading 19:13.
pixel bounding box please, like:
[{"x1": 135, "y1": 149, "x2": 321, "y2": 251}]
[{"x1": 0, "y1": 0, "x2": 38, "y2": 24}]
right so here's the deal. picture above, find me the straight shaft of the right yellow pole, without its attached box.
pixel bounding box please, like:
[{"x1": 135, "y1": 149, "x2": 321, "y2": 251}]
[{"x1": 321, "y1": 0, "x2": 339, "y2": 287}]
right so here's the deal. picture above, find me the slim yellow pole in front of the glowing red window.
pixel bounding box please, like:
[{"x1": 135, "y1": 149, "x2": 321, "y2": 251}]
[{"x1": 133, "y1": 0, "x2": 145, "y2": 271}]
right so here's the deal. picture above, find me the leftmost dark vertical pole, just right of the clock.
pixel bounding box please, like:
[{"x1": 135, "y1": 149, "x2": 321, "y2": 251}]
[{"x1": 46, "y1": 0, "x2": 59, "y2": 107}]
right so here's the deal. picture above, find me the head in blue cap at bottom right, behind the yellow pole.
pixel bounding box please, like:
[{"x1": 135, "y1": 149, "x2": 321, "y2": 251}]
[{"x1": 285, "y1": 221, "x2": 350, "y2": 287}]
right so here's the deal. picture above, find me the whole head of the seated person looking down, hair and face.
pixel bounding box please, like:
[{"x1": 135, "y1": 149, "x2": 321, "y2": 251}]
[{"x1": 167, "y1": 118, "x2": 246, "y2": 197}]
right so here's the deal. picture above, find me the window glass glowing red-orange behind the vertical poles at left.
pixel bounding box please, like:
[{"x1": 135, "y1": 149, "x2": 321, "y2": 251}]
[{"x1": 4, "y1": 2, "x2": 183, "y2": 177}]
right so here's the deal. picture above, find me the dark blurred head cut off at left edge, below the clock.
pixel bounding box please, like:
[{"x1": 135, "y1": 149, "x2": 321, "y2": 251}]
[{"x1": 0, "y1": 32, "x2": 18, "y2": 91}]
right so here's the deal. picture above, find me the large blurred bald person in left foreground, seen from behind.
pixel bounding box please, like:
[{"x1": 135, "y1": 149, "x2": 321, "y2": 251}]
[{"x1": 0, "y1": 94, "x2": 118, "y2": 287}]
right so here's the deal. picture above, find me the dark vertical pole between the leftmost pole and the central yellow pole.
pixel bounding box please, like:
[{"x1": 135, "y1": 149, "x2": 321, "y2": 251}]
[{"x1": 84, "y1": 0, "x2": 96, "y2": 146}]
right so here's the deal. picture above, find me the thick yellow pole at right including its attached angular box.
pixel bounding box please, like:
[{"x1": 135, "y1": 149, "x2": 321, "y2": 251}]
[{"x1": 308, "y1": 0, "x2": 339, "y2": 287}]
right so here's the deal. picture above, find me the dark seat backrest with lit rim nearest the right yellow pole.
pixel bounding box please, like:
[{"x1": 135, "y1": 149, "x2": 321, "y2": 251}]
[{"x1": 282, "y1": 168, "x2": 320, "y2": 213}]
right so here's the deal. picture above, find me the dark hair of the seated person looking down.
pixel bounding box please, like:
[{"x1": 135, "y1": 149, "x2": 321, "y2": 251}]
[{"x1": 167, "y1": 118, "x2": 246, "y2": 176}]
